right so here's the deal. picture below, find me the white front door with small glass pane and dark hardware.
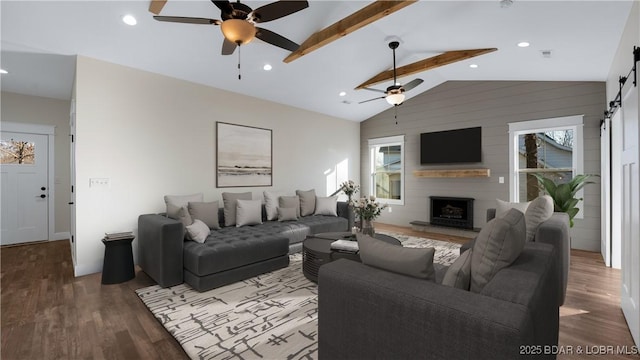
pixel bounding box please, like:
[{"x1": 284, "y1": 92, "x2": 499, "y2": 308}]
[{"x1": 0, "y1": 132, "x2": 49, "y2": 245}]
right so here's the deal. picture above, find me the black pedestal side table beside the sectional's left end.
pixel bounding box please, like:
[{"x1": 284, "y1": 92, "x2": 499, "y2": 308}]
[{"x1": 102, "y1": 237, "x2": 136, "y2": 284}]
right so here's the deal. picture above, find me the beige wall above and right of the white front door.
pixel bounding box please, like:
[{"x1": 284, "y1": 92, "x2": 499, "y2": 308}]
[{"x1": 1, "y1": 92, "x2": 71, "y2": 238}]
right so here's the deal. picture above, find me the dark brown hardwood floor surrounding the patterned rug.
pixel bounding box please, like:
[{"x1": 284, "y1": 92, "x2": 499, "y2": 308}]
[{"x1": 0, "y1": 224, "x2": 639, "y2": 359}]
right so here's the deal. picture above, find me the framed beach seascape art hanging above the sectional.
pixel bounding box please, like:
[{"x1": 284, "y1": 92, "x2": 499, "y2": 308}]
[{"x1": 216, "y1": 122, "x2": 273, "y2": 188}]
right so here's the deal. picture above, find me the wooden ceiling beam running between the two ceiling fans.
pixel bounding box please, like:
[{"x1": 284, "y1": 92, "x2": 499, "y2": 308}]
[{"x1": 283, "y1": 0, "x2": 417, "y2": 63}]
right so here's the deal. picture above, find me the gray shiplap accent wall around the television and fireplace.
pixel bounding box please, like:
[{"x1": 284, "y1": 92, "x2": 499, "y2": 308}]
[{"x1": 360, "y1": 81, "x2": 606, "y2": 251}]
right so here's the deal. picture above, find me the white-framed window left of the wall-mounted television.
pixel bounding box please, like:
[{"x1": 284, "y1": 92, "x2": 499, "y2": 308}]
[{"x1": 369, "y1": 135, "x2": 404, "y2": 205}]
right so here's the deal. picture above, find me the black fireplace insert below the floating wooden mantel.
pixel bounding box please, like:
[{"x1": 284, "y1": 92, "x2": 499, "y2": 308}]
[{"x1": 429, "y1": 196, "x2": 474, "y2": 229}]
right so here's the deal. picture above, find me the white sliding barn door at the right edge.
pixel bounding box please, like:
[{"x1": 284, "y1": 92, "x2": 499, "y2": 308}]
[{"x1": 620, "y1": 87, "x2": 640, "y2": 345}]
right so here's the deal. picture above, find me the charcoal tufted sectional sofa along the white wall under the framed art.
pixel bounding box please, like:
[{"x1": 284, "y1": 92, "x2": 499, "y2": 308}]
[{"x1": 138, "y1": 202, "x2": 353, "y2": 291}]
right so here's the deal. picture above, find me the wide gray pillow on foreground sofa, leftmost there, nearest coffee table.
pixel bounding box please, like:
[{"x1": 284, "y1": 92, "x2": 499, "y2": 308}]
[{"x1": 356, "y1": 233, "x2": 436, "y2": 281}]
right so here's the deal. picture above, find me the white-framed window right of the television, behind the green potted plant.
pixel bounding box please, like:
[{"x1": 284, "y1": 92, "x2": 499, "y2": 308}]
[{"x1": 509, "y1": 115, "x2": 583, "y2": 213}]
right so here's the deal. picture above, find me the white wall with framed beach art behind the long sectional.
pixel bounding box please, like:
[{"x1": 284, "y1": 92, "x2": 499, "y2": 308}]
[{"x1": 75, "y1": 57, "x2": 360, "y2": 275}]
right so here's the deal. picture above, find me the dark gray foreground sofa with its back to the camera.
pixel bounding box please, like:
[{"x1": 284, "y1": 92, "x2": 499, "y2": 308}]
[{"x1": 318, "y1": 208, "x2": 569, "y2": 360}]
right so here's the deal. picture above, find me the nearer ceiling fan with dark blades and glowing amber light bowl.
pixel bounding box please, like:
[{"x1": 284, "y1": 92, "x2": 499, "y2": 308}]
[{"x1": 153, "y1": 0, "x2": 309, "y2": 55}]
